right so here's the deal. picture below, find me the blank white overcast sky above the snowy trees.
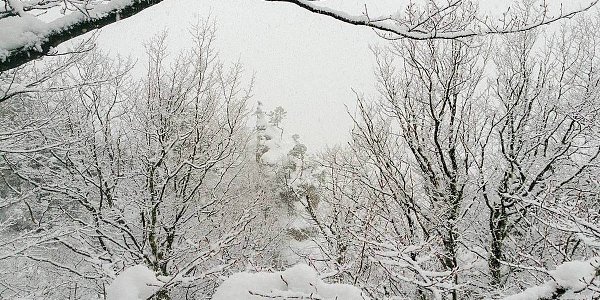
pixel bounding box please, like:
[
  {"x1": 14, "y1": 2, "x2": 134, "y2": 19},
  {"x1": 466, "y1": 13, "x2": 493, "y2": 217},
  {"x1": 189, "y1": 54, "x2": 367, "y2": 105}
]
[{"x1": 91, "y1": 0, "x2": 583, "y2": 151}]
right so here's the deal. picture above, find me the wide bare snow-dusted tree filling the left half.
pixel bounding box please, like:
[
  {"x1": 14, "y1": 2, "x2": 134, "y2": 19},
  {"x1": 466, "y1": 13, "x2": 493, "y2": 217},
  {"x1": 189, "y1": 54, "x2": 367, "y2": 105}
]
[{"x1": 3, "y1": 23, "x2": 254, "y2": 299}]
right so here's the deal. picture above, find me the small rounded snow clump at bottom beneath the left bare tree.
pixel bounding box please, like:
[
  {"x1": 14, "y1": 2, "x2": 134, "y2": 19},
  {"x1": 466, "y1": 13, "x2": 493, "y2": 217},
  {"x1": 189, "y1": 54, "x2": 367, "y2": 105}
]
[{"x1": 106, "y1": 265, "x2": 163, "y2": 300}]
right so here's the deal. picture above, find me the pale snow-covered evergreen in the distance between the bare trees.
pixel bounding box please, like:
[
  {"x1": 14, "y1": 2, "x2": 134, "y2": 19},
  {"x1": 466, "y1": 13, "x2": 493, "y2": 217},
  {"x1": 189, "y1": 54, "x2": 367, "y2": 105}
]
[{"x1": 256, "y1": 103, "x2": 330, "y2": 268}]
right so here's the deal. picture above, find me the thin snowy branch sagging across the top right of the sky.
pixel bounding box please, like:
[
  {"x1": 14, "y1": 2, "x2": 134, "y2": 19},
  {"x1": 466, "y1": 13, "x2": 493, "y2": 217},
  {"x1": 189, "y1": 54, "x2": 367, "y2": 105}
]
[{"x1": 265, "y1": 0, "x2": 599, "y2": 40}]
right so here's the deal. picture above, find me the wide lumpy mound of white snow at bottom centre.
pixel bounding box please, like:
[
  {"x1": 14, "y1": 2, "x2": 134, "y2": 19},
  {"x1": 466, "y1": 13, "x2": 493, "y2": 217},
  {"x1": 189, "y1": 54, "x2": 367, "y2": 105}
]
[{"x1": 212, "y1": 264, "x2": 368, "y2": 300}]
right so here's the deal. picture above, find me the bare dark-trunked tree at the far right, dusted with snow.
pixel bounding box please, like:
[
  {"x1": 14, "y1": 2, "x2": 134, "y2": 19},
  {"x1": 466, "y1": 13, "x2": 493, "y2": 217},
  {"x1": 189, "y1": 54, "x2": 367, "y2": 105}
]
[{"x1": 481, "y1": 13, "x2": 600, "y2": 296}]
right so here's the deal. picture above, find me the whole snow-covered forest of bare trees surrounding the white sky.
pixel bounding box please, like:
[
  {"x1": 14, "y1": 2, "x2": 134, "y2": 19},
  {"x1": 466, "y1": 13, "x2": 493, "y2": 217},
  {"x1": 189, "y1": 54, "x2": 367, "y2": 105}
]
[{"x1": 0, "y1": 0, "x2": 600, "y2": 300}]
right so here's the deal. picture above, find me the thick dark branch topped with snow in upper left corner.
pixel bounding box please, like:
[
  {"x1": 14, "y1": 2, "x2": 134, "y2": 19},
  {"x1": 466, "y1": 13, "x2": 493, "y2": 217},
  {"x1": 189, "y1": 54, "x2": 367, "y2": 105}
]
[{"x1": 0, "y1": 0, "x2": 162, "y2": 72}]
